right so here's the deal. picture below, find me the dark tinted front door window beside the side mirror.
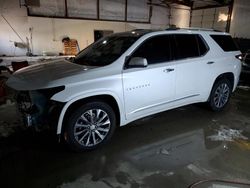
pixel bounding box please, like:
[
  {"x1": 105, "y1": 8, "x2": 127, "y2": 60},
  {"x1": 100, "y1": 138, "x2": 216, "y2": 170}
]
[{"x1": 132, "y1": 35, "x2": 171, "y2": 64}]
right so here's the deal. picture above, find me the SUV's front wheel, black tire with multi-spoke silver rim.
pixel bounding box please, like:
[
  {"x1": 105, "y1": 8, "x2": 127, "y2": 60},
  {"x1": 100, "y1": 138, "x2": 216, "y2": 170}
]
[{"x1": 64, "y1": 101, "x2": 116, "y2": 152}]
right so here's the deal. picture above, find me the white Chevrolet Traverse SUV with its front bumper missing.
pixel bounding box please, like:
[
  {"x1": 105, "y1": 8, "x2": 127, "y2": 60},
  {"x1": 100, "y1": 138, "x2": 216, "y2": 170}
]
[{"x1": 7, "y1": 29, "x2": 241, "y2": 150}]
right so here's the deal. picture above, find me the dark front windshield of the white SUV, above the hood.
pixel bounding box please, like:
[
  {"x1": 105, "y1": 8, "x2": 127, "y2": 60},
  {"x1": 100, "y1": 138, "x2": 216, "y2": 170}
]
[{"x1": 74, "y1": 35, "x2": 139, "y2": 66}]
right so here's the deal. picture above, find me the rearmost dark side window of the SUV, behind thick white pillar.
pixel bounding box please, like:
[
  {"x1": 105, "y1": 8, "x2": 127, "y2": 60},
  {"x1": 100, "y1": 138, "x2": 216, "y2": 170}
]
[{"x1": 210, "y1": 35, "x2": 239, "y2": 52}]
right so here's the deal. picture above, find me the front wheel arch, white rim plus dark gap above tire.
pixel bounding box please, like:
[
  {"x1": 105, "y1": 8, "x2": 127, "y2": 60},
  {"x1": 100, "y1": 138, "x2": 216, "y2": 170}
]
[{"x1": 57, "y1": 94, "x2": 122, "y2": 135}]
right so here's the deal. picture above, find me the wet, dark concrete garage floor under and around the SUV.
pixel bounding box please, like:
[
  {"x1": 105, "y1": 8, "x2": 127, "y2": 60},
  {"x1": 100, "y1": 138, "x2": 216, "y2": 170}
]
[{"x1": 0, "y1": 87, "x2": 250, "y2": 188}]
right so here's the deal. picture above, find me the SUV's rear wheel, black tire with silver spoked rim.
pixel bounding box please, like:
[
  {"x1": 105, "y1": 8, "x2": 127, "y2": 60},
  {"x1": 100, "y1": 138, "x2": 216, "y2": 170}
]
[{"x1": 208, "y1": 79, "x2": 232, "y2": 111}]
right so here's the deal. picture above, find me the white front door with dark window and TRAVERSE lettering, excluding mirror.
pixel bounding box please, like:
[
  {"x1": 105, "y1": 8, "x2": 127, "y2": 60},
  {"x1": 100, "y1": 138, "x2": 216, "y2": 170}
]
[{"x1": 122, "y1": 35, "x2": 176, "y2": 119}]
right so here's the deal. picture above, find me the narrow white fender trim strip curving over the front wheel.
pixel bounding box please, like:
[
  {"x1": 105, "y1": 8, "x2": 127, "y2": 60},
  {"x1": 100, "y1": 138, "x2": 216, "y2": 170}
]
[{"x1": 56, "y1": 91, "x2": 125, "y2": 134}]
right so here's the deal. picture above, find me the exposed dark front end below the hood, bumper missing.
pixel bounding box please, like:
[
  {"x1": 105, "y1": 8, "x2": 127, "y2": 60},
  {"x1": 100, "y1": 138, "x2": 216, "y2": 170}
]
[{"x1": 16, "y1": 86, "x2": 65, "y2": 130}]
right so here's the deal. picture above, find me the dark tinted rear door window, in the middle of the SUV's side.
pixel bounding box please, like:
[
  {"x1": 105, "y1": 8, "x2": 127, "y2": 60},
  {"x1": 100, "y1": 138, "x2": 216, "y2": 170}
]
[{"x1": 174, "y1": 34, "x2": 200, "y2": 60}]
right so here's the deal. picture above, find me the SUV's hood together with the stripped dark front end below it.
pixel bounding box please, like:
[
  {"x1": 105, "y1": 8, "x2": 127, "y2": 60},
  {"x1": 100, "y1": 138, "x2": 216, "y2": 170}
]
[{"x1": 6, "y1": 59, "x2": 91, "y2": 131}]
